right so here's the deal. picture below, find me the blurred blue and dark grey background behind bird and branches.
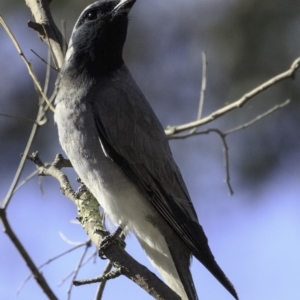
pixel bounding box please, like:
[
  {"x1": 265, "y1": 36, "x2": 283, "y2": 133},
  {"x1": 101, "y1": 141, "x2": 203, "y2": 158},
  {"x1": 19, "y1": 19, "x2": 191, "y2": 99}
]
[{"x1": 0, "y1": 0, "x2": 300, "y2": 300}]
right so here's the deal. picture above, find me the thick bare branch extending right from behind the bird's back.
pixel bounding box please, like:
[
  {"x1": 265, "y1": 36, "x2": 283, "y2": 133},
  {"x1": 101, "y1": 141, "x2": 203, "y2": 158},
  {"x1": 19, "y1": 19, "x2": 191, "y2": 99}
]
[{"x1": 165, "y1": 57, "x2": 300, "y2": 138}]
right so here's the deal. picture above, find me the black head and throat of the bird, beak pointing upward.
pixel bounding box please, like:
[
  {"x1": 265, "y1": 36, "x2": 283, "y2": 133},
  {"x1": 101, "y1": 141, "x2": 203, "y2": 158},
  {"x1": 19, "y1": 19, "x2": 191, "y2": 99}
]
[{"x1": 63, "y1": 0, "x2": 136, "y2": 75}]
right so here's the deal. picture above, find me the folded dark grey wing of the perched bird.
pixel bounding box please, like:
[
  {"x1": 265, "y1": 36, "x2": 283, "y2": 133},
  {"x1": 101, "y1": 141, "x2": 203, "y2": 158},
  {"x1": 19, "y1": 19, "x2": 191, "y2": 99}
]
[{"x1": 91, "y1": 67, "x2": 235, "y2": 300}]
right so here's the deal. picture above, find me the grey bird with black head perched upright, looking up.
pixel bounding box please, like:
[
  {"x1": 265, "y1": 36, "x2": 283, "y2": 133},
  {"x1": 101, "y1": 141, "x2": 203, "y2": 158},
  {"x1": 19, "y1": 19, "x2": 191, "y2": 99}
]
[{"x1": 54, "y1": 0, "x2": 238, "y2": 300}]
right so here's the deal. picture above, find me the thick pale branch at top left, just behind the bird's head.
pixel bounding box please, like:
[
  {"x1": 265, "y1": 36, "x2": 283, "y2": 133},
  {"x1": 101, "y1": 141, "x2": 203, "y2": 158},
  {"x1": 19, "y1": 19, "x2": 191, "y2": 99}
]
[{"x1": 25, "y1": 0, "x2": 66, "y2": 68}]
